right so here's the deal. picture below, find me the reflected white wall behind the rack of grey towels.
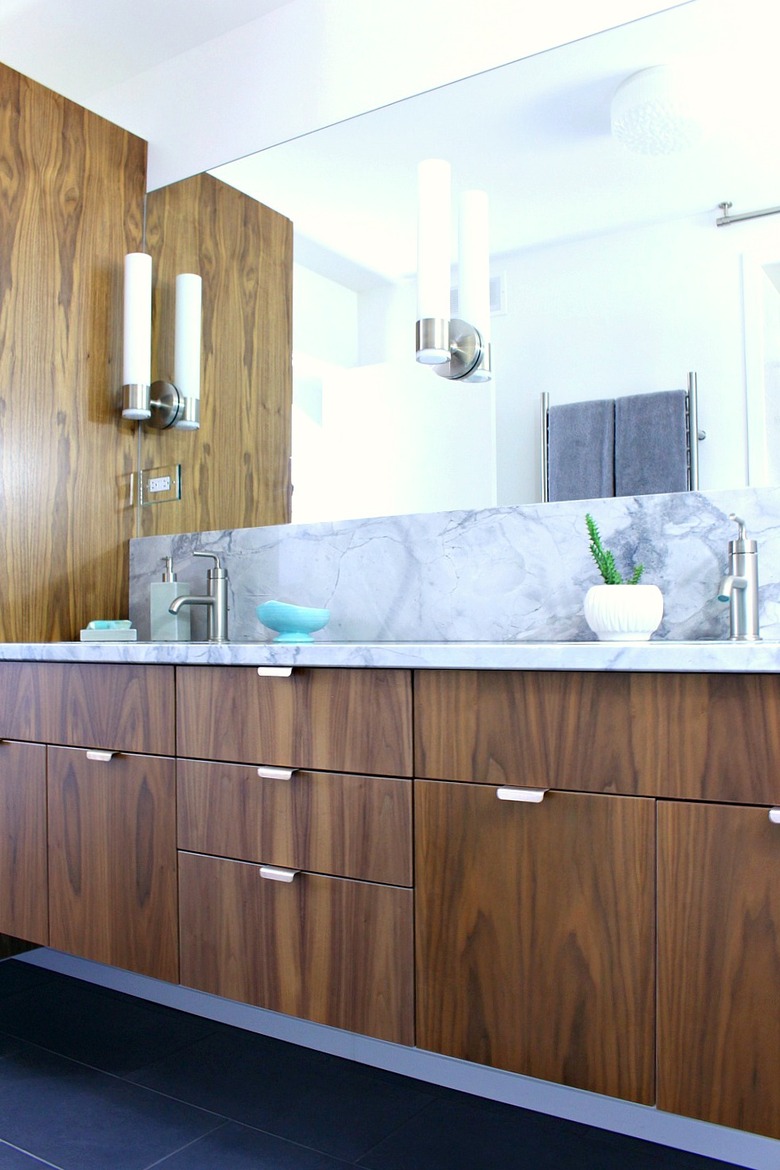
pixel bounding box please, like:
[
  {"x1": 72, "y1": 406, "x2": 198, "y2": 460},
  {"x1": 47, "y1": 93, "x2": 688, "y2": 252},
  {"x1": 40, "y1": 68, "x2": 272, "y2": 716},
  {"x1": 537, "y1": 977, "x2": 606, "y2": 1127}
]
[{"x1": 493, "y1": 215, "x2": 748, "y2": 503}]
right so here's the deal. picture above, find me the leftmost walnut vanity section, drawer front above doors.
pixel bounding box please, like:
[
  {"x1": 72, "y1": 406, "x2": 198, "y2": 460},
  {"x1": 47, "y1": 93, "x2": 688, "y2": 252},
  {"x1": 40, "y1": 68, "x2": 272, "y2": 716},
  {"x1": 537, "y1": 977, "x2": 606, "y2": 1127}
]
[{"x1": 0, "y1": 662, "x2": 179, "y2": 982}]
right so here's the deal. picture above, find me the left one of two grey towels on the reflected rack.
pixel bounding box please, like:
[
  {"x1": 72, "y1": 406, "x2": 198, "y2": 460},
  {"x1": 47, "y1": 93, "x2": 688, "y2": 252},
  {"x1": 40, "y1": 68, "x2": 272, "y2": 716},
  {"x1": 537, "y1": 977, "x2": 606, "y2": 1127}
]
[{"x1": 547, "y1": 399, "x2": 615, "y2": 500}]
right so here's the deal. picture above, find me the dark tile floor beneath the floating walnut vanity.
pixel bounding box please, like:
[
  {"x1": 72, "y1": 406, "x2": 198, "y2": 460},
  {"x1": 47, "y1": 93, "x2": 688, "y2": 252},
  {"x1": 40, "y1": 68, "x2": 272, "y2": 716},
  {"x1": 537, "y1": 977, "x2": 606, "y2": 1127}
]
[{"x1": 0, "y1": 959, "x2": 748, "y2": 1170}]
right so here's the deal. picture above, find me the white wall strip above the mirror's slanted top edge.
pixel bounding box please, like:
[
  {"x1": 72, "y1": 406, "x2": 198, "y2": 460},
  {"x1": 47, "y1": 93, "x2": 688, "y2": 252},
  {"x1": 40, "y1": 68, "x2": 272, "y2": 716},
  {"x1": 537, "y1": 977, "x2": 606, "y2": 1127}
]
[{"x1": 85, "y1": 0, "x2": 679, "y2": 190}]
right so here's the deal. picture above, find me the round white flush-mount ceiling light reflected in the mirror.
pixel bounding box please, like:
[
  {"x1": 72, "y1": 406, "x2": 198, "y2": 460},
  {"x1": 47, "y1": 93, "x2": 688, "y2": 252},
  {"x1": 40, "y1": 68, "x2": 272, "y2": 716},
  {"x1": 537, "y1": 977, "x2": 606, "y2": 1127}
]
[{"x1": 610, "y1": 66, "x2": 709, "y2": 154}]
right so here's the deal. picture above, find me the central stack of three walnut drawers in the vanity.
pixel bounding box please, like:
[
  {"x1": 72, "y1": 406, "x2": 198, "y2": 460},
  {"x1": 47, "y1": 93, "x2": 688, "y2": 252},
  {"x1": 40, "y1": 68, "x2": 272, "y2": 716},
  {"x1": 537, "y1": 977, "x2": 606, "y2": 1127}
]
[{"x1": 178, "y1": 667, "x2": 414, "y2": 1044}]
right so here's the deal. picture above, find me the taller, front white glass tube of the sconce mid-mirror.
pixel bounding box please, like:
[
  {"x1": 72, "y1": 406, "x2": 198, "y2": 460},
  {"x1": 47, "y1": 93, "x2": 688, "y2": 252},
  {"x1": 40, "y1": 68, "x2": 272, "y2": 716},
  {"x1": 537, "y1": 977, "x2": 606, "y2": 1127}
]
[{"x1": 417, "y1": 158, "x2": 451, "y2": 363}]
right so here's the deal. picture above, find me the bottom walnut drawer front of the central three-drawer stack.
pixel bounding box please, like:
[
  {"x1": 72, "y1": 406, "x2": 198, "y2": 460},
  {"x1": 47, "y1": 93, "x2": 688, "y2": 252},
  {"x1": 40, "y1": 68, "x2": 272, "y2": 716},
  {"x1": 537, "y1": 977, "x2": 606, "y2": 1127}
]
[{"x1": 179, "y1": 853, "x2": 414, "y2": 1044}]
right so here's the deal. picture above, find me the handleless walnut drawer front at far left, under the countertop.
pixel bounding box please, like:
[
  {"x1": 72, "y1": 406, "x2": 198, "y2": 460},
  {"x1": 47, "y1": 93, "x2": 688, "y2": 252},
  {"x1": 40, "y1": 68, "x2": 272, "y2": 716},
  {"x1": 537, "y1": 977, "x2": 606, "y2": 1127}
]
[{"x1": 0, "y1": 662, "x2": 175, "y2": 756}]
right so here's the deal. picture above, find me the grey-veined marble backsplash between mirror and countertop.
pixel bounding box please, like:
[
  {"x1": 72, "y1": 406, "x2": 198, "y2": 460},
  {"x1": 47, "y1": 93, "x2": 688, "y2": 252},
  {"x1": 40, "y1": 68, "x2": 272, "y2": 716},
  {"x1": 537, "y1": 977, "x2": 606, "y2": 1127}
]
[{"x1": 130, "y1": 488, "x2": 780, "y2": 642}]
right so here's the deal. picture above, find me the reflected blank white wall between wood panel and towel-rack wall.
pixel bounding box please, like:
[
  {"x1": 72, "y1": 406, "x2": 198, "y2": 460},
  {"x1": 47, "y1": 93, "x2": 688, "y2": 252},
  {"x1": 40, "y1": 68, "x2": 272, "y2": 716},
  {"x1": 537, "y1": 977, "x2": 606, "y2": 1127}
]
[{"x1": 292, "y1": 264, "x2": 496, "y2": 523}]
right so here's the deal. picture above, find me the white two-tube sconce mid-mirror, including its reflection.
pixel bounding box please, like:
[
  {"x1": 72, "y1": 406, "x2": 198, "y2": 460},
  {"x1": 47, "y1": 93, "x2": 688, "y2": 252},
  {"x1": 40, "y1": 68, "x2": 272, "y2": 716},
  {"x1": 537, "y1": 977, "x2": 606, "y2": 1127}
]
[{"x1": 415, "y1": 159, "x2": 491, "y2": 381}]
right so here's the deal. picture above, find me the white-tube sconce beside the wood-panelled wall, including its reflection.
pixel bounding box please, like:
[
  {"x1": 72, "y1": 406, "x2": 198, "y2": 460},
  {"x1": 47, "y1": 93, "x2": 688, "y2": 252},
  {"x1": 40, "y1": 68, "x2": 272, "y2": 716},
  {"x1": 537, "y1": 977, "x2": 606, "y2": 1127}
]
[{"x1": 122, "y1": 252, "x2": 202, "y2": 431}]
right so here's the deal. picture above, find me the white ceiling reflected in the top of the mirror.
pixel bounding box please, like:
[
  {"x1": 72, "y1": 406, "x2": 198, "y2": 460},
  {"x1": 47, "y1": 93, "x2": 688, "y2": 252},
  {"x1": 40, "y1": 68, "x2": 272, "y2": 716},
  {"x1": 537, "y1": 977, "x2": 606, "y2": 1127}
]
[{"x1": 213, "y1": 0, "x2": 780, "y2": 288}]
